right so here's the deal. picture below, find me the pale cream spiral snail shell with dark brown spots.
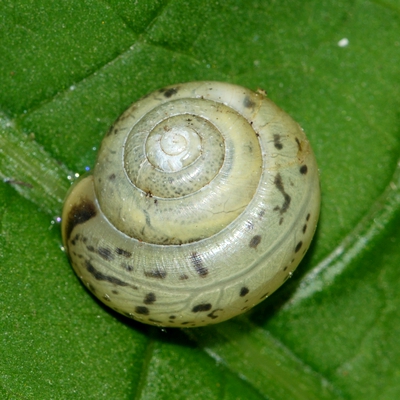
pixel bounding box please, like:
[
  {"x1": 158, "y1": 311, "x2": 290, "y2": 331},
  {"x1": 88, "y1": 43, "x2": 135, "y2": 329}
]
[{"x1": 61, "y1": 82, "x2": 320, "y2": 328}]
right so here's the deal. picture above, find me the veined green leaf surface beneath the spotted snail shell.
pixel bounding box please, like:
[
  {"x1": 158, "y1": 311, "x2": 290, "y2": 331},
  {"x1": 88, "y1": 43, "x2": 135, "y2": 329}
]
[{"x1": 0, "y1": 0, "x2": 400, "y2": 400}]
